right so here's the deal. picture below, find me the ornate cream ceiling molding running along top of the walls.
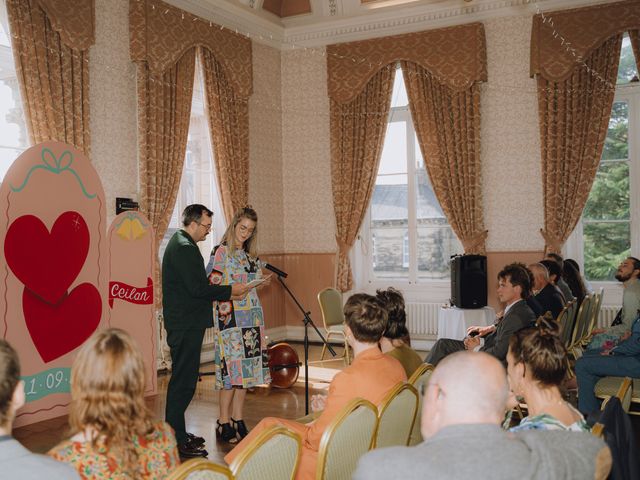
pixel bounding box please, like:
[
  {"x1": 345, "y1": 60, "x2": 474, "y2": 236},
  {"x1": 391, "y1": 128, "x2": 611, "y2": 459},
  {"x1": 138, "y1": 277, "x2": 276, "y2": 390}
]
[{"x1": 165, "y1": 0, "x2": 610, "y2": 50}]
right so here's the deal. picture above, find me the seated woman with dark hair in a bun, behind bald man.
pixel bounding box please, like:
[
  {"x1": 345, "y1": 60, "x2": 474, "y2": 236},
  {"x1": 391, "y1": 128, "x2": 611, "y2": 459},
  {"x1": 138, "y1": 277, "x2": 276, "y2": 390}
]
[{"x1": 507, "y1": 316, "x2": 589, "y2": 432}]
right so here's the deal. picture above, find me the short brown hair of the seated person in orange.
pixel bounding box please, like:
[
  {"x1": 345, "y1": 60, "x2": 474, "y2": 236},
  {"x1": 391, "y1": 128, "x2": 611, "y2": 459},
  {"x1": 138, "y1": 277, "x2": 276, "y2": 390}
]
[{"x1": 344, "y1": 293, "x2": 388, "y2": 343}]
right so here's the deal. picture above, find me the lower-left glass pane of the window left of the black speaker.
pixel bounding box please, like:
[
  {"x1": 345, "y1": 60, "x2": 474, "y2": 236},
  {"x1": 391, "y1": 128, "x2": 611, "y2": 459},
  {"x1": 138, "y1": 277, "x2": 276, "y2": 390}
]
[{"x1": 371, "y1": 228, "x2": 409, "y2": 278}]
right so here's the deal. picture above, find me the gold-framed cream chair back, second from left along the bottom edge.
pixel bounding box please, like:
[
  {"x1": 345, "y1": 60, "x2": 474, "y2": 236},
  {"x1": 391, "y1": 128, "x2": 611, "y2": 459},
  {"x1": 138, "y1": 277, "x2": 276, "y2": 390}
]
[{"x1": 229, "y1": 426, "x2": 302, "y2": 480}]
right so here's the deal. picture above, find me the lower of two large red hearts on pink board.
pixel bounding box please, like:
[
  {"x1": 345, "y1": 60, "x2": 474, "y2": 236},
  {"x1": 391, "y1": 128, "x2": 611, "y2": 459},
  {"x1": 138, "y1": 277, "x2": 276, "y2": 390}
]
[{"x1": 22, "y1": 283, "x2": 102, "y2": 363}]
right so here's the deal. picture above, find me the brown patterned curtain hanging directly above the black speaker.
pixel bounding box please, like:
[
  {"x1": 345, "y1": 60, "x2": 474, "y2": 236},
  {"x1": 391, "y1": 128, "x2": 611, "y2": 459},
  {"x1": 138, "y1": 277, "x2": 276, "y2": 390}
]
[{"x1": 401, "y1": 61, "x2": 487, "y2": 254}]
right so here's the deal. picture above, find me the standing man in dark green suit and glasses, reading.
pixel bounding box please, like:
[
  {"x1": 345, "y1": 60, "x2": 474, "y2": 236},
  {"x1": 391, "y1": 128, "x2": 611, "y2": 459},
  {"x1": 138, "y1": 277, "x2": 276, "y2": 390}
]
[{"x1": 162, "y1": 204, "x2": 249, "y2": 457}]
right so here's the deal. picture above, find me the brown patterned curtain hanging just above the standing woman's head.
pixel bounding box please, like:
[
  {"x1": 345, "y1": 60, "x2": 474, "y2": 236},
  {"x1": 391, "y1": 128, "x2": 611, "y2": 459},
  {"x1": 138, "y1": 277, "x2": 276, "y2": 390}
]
[{"x1": 200, "y1": 48, "x2": 249, "y2": 222}]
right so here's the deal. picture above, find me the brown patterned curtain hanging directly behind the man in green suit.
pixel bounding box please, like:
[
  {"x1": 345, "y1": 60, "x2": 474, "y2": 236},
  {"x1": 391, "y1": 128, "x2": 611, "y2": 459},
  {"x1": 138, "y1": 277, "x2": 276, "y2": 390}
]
[{"x1": 137, "y1": 47, "x2": 196, "y2": 306}]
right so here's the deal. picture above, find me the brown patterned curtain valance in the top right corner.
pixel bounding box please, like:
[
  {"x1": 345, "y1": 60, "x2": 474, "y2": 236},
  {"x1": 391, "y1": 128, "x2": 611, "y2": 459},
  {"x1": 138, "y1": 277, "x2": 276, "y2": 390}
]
[{"x1": 531, "y1": 0, "x2": 640, "y2": 82}]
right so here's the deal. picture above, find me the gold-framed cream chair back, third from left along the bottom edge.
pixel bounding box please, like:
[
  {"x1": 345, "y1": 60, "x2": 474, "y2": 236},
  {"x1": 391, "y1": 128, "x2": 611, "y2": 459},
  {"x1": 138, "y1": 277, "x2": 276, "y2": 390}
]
[{"x1": 316, "y1": 398, "x2": 378, "y2": 480}]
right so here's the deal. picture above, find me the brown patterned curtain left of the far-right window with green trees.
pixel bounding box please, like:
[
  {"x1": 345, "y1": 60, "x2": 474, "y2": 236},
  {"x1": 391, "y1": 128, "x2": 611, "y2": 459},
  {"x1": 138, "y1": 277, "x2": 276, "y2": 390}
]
[{"x1": 537, "y1": 34, "x2": 622, "y2": 253}]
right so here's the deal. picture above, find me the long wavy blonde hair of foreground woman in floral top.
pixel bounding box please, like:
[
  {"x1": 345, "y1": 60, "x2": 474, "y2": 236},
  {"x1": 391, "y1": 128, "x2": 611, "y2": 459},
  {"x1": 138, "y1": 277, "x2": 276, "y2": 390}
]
[{"x1": 69, "y1": 328, "x2": 153, "y2": 478}]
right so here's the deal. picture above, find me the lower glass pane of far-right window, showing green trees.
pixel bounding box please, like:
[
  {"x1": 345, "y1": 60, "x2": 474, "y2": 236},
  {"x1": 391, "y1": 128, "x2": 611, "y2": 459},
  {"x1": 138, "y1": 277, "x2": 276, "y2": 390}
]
[{"x1": 583, "y1": 222, "x2": 631, "y2": 281}]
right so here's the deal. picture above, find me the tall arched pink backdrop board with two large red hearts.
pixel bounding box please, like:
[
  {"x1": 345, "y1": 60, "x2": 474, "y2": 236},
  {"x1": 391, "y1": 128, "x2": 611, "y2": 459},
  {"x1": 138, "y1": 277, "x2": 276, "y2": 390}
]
[{"x1": 0, "y1": 142, "x2": 108, "y2": 426}]
